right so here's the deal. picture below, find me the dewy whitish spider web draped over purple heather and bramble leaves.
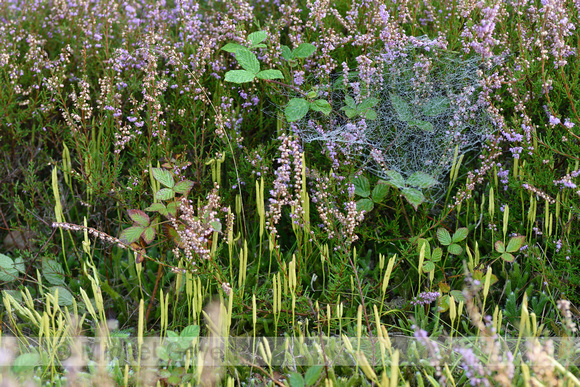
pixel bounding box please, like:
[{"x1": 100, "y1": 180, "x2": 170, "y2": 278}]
[{"x1": 291, "y1": 39, "x2": 494, "y2": 199}]
